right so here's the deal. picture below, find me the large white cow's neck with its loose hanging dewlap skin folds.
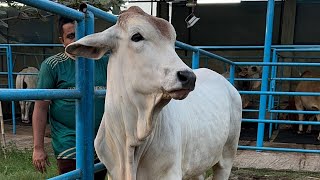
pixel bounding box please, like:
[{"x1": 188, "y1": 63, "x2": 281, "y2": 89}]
[{"x1": 105, "y1": 57, "x2": 169, "y2": 180}]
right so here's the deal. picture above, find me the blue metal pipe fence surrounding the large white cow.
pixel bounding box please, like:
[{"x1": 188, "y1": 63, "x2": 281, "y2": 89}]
[{"x1": 0, "y1": 0, "x2": 320, "y2": 179}]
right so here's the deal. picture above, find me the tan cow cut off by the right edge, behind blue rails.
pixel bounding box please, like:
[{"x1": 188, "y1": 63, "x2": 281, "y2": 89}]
[{"x1": 294, "y1": 71, "x2": 320, "y2": 140}]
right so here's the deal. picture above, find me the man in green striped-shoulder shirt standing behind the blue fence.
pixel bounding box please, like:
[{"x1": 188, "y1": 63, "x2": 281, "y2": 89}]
[{"x1": 32, "y1": 17, "x2": 107, "y2": 179}]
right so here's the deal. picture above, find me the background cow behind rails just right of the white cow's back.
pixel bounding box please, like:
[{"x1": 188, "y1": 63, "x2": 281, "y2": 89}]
[{"x1": 222, "y1": 66, "x2": 261, "y2": 109}]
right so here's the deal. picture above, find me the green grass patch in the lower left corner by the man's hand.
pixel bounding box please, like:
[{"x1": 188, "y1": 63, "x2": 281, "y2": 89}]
[{"x1": 0, "y1": 144, "x2": 58, "y2": 180}]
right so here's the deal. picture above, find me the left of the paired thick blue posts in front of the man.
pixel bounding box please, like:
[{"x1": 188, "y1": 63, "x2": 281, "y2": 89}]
[{"x1": 76, "y1": 20, "x2": 85, "y2": 177}]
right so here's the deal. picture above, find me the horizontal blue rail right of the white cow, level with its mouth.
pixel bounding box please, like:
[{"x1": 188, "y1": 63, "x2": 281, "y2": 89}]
[{"x1": 239, "y1": 91, "x2": 320, "y2": 96}]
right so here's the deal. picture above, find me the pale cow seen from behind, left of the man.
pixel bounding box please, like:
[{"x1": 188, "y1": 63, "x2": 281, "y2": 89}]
[{"x1": 16, "y1": 67, "x2": 39, "y2": 123}]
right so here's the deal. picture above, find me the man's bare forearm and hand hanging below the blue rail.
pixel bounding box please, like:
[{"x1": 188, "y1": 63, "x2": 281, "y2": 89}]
[{"x1": 32, "y1": 101, "x2": 50, "y2": 173}]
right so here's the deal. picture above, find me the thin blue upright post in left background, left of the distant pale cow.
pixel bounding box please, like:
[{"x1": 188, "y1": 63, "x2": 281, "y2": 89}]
[{"x1": 6, "y1": 45, "x2": 16, "y2": 134}]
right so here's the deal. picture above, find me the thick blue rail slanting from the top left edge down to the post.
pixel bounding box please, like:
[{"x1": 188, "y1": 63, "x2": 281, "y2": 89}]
[{"x1": 15, "y1": 0, "x2": 84, "y2": 21}]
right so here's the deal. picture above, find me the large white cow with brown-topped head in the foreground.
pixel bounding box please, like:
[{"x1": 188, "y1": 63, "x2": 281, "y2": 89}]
[{"x1": 66, "y1": 7, "x2": 242, "y2": 180}]
